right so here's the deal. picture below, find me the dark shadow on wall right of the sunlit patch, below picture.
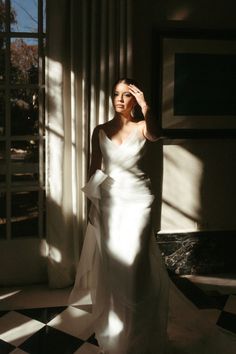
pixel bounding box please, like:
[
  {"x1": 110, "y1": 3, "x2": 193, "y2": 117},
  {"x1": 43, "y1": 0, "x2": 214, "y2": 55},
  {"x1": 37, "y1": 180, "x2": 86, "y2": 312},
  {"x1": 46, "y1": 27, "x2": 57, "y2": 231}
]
[{"x1": 183, "y1": 139, "x2": 236, "y2": 231}]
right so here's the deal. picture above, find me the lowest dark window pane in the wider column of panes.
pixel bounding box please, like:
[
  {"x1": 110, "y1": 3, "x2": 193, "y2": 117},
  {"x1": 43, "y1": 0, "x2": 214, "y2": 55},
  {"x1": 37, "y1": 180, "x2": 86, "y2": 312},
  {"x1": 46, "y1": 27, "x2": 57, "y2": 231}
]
[{"x1": 11, "y1": 192, "x2": 38, "y2": 238}]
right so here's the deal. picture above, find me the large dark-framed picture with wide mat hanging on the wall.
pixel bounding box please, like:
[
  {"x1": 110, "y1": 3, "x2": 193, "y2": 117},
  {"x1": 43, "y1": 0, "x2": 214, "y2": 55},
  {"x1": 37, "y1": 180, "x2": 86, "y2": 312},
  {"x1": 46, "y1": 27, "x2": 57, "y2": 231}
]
[{"x1": 160, "y1": 33, "x2": 236, "y2": 134}]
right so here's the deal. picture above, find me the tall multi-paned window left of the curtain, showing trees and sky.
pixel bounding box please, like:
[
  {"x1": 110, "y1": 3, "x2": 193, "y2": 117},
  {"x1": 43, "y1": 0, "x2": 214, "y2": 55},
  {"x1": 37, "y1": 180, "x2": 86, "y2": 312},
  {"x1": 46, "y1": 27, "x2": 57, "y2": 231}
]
[{"x1": 0, "y1": 0, "x2": 46, "y2": 240}]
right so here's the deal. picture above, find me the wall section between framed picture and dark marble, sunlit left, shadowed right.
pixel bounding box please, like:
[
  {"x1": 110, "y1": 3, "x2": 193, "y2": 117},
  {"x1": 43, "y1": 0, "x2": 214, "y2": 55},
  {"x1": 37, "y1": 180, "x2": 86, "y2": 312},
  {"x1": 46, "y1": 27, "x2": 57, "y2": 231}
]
[{"x1": 162, "y1": 139, "x2": 236, "y2": 232}]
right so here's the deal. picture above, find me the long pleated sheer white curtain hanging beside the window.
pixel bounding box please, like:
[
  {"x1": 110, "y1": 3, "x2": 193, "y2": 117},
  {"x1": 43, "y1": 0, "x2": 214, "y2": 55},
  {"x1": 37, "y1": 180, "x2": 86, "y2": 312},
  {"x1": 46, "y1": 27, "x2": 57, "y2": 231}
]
[{"x1": 46, "y1": 0, "x2": 132, "y2": 287}]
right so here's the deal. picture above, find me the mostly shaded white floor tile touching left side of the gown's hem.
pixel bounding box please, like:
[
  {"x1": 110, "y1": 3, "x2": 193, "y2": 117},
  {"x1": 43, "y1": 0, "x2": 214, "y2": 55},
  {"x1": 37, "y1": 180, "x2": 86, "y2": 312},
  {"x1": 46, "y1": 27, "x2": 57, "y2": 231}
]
[{"x1": 48, "y1": 306, "x2": 94, "y2": 340}]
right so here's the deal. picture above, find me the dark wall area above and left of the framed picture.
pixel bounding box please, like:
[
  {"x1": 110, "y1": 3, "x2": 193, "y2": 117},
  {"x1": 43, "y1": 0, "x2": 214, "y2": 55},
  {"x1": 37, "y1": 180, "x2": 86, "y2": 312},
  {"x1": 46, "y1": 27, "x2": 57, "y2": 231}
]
[{"x1": 133, "y1": 0, "x2": 236, "y2": 94}]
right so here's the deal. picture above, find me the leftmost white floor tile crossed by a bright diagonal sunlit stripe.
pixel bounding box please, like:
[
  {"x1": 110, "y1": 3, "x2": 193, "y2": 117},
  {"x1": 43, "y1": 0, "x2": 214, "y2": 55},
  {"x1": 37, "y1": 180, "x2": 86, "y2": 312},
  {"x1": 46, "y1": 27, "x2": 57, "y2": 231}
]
[{"x1": 0, "y1": 311, "x2": 44, "y2": 346}]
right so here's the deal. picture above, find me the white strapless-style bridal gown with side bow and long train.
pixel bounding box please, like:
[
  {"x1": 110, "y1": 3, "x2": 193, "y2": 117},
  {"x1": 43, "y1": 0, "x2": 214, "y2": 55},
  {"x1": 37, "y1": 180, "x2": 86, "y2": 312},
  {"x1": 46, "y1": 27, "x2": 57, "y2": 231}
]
[{"x1": 69, "y1": 128, "x2": 236, "y2": 354}]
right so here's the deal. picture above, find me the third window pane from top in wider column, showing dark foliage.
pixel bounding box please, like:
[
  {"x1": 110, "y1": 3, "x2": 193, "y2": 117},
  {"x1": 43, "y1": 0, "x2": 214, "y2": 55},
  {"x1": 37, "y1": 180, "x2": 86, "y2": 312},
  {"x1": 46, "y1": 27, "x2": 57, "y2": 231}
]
[{"x1": 11, "y1": 89, "x2": 39, "y2": 135}]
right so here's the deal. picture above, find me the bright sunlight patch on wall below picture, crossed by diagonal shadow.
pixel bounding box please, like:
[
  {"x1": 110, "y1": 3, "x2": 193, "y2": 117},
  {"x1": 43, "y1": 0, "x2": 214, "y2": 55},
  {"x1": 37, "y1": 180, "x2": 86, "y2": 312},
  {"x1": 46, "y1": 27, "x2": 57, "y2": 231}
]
[{"x1": 161, "y1": 145, "x2": 203, "y2": 232}]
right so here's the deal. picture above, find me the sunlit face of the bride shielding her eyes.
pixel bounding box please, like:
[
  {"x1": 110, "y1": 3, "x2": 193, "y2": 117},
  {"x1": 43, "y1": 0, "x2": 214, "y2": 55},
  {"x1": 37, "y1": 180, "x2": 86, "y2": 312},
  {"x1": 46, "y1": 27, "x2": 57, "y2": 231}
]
[{"x1": 113, "y1": 82, "x2": 136, "y2": 114}]
